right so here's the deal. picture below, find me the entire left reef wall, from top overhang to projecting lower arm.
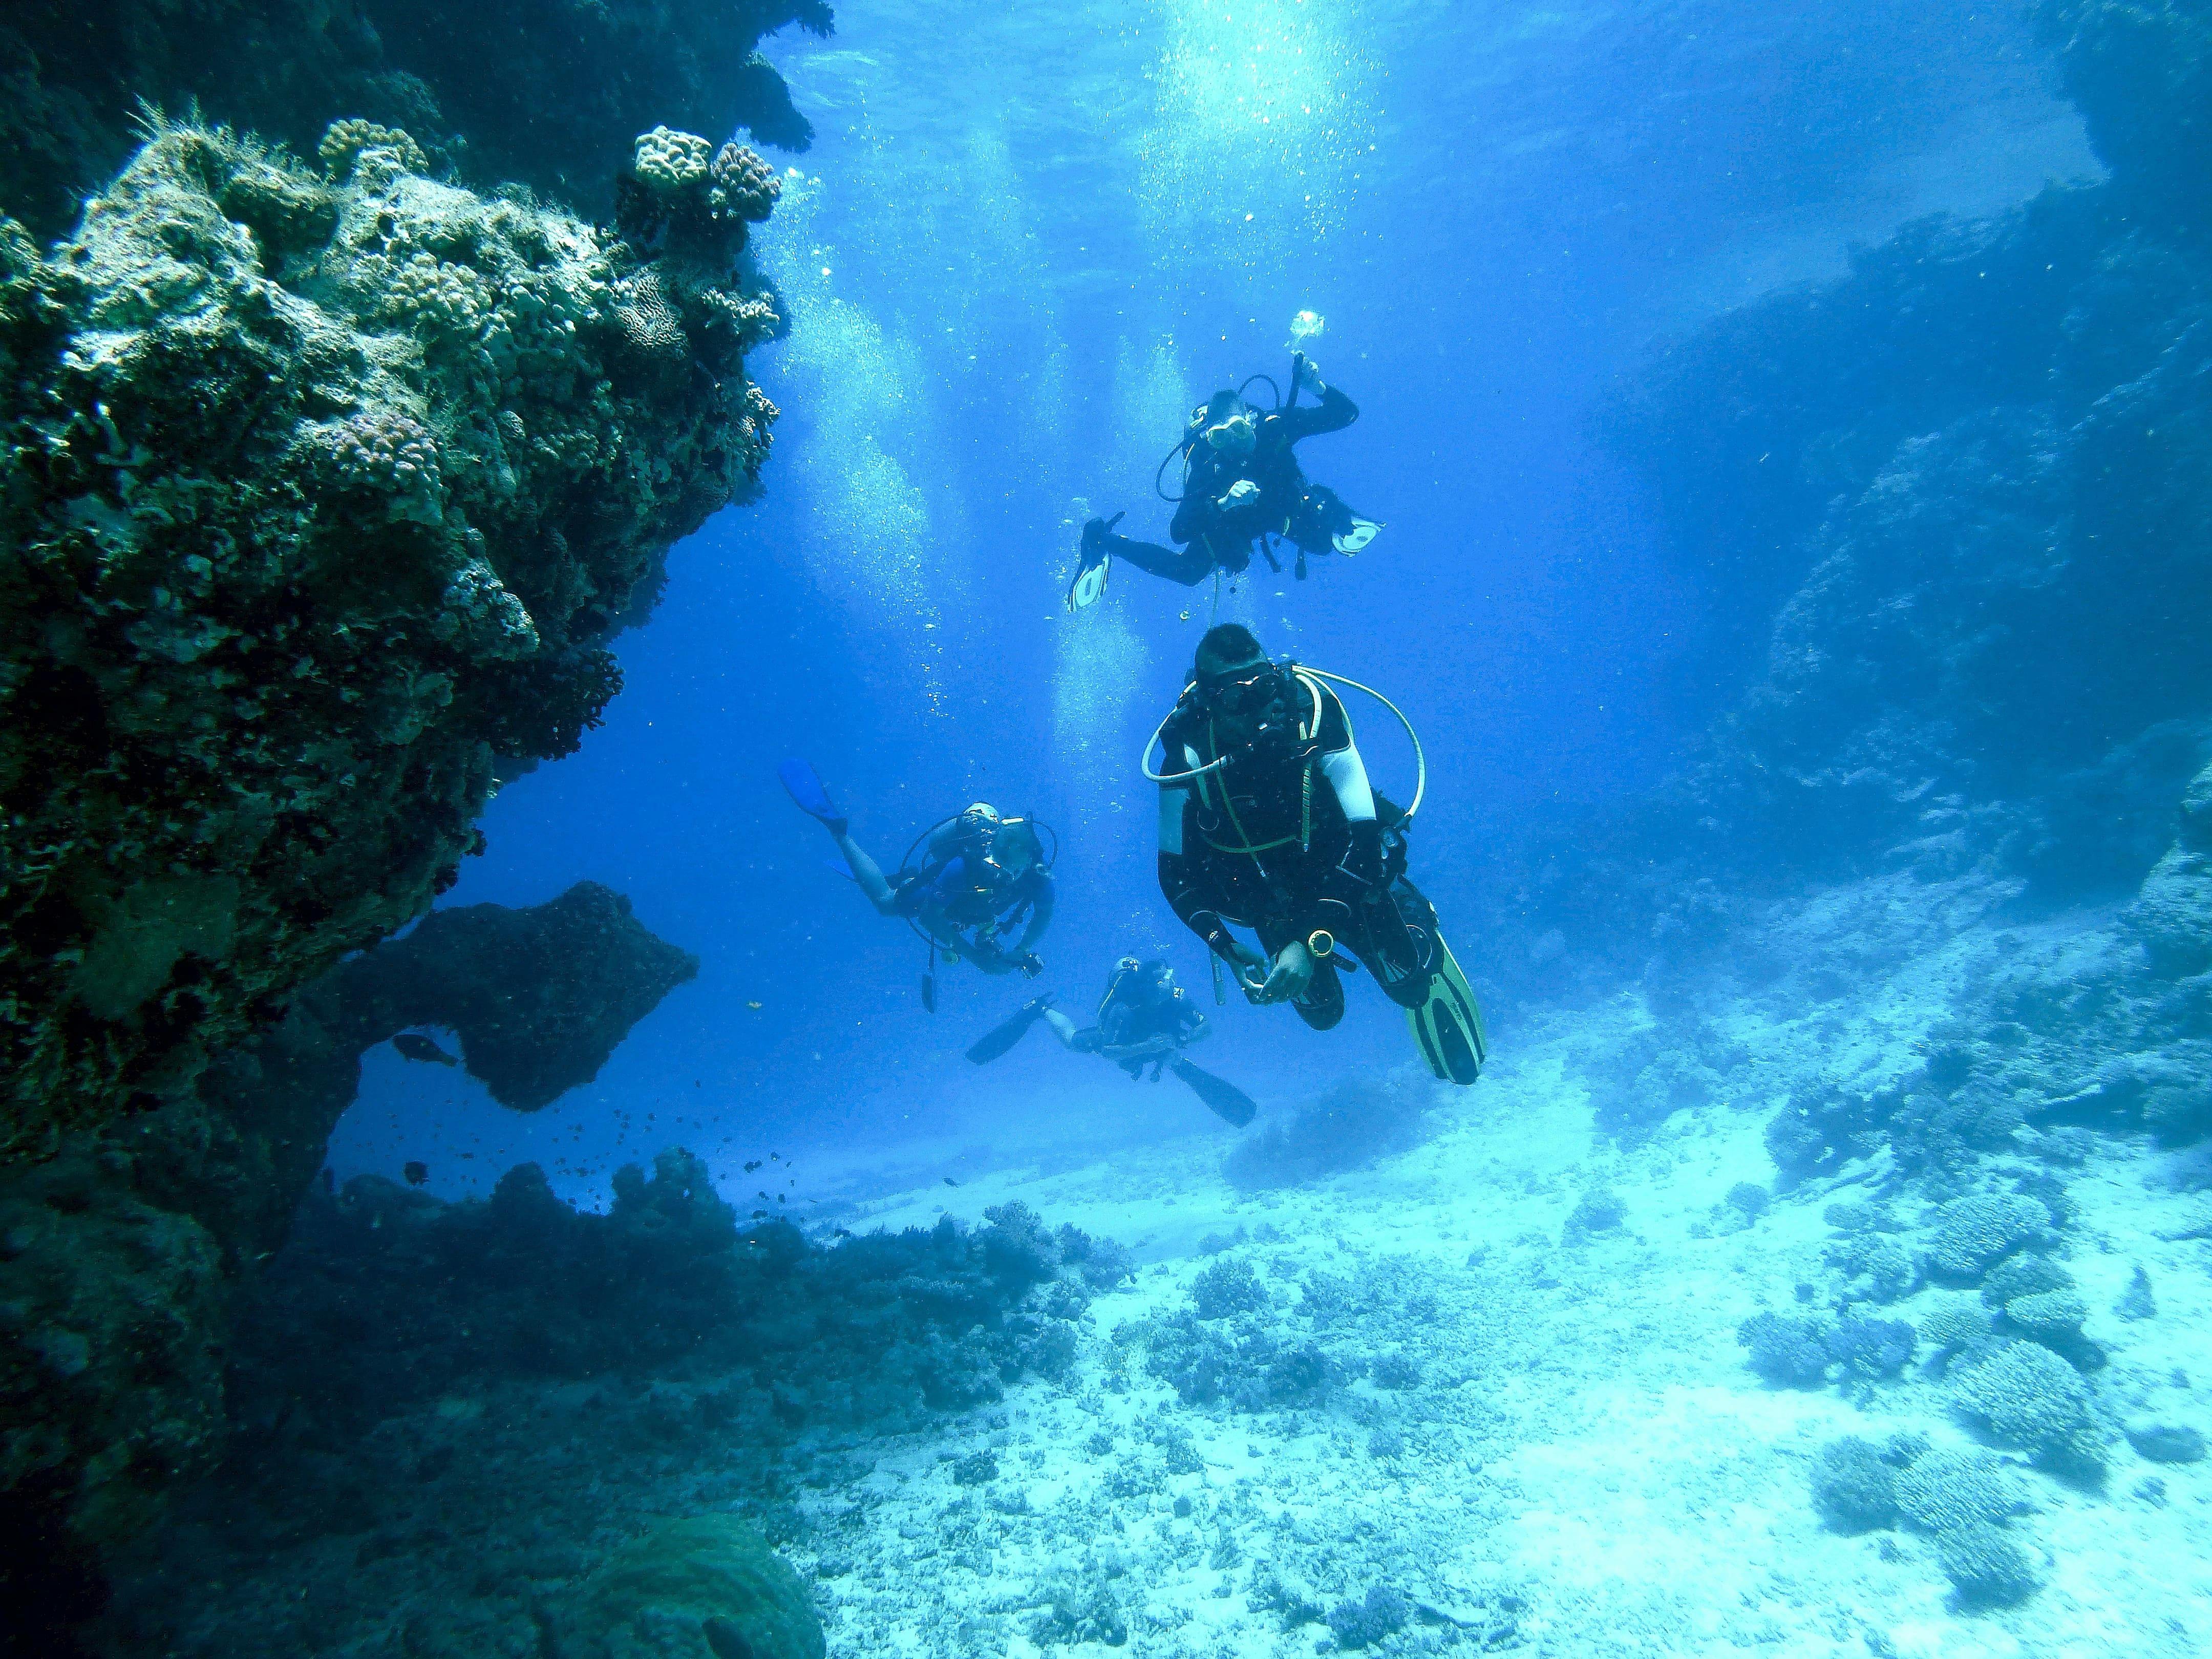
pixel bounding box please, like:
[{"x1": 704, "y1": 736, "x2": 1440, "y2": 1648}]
[{"x1": 0, "y1": 0, "x2": 830, "y2": 1650}]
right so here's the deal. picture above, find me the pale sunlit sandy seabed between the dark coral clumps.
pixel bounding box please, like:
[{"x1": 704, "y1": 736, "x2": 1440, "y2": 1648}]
[{"x1": 794, "y1": 924, "x2": 2212, "y2": 1659}]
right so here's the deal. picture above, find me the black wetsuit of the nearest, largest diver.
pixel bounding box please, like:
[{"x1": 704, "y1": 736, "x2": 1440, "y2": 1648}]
[{"x1": 1159, "y1": 679, "x2": 1436, "y2": 1031}]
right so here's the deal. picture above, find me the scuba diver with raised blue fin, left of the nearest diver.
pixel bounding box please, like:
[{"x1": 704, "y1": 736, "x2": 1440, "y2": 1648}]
[{"x1": 776, "y1": 761, "x2": 1057, "y2": 1013}]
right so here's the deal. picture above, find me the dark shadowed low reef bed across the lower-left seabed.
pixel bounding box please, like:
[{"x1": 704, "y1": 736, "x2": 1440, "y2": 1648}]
[{"x1": 95, "y1": 1185, "x2": 1121, "y2": 1659}]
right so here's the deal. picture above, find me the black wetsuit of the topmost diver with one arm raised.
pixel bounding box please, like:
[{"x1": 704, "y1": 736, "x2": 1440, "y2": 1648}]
[{"x1": 1106, "y1": 387, "x2": 1360, "y2": 588}]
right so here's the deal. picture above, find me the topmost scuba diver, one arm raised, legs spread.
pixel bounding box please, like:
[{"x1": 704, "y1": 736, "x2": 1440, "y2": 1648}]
[{"x1": 1069, "y1": 352, "x2": 1382, "y2": 610}]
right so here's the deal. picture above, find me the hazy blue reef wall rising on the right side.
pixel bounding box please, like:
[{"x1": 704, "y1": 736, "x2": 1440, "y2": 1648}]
[{"x1": 1498, "y1": 0, "x2": 2212, "y2": 989}]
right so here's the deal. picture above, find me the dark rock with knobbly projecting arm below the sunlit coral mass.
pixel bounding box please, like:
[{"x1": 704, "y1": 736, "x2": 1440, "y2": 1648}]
[{"x1": 0, "y1": 883, "x2": 699, "y2": 1639}]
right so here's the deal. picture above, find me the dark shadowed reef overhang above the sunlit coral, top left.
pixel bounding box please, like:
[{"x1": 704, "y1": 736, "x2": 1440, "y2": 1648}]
[{"x1": 0, "y1": 0, "x2": 830, "y2": 235}]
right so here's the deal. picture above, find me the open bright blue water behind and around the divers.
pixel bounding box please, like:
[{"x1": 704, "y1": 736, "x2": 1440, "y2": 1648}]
[{"x1": 332, "y1": 0, "x2": 2097, "y2": 1203}]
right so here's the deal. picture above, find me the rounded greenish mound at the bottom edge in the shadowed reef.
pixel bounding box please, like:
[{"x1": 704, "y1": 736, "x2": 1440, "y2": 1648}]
[{"x1": 555, "y1": 1515, "x2": 823, "y2": 1659}]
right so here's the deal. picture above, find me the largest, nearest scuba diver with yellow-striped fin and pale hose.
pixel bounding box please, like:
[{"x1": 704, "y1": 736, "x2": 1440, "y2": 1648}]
[{"x1": 1143, "y1": 622, "x2": 1486, "y2": 1084}]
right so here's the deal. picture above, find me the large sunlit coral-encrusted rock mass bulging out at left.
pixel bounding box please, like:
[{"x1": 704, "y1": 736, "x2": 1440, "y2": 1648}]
[{"x1": 0, "y1": 124, "x2": 776, "y2": 1157}]
